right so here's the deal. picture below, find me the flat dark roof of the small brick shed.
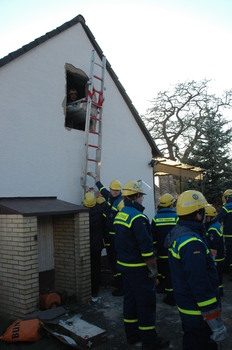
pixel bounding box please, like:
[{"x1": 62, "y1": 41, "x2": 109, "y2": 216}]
[{"x1": 0, "y1": 197, "x2": 89, "y2": 216}]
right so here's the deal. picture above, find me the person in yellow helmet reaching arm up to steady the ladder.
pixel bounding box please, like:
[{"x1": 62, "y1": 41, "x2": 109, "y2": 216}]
[{"x1": 88, "y1": 172, "x2": 123, "y2": 296}]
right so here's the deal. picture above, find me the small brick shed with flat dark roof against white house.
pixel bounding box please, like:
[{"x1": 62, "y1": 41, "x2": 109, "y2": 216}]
[{"x1": 0, "y1": 197, "x2": 91, "y2": 317}]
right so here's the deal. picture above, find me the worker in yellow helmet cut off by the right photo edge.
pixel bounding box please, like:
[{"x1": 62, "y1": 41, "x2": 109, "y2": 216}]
[{"x1": 217, "y1": 189, "x2": 232, "y2": 272}]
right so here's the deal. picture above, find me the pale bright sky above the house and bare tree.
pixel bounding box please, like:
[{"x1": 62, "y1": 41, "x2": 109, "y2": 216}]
[{"x1": 0, "y1": 0, "x2": 232, "y2": 114}]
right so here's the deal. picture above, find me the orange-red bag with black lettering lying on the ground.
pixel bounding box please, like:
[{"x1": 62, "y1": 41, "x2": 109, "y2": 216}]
[{"x1": 0, "y1": 318, "x2": 42, "y2": 343}]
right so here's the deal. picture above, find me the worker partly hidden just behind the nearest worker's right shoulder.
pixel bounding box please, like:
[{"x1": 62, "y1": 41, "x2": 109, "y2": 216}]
[{"x1": 205, "y1": 205, "x2": 225, "y2": 296}]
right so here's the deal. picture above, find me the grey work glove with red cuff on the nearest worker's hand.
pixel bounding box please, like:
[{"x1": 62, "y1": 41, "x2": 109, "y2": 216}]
[{"x1": 202, "y1": 309, "x2": 228, "y2": 343}]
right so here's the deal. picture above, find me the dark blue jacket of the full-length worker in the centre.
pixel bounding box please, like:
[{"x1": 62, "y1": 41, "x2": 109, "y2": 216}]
[{"x1": 114, "y1": 198, "x2": 154, "y2": 271}]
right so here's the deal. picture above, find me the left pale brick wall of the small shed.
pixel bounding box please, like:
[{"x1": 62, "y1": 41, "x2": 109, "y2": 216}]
[{"x1": 0, "y1": 215, "x2": 39, "y2": 317}]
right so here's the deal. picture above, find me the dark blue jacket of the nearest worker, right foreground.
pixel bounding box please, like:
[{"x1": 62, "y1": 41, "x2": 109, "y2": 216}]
[{"x1": 165, "y1": 219, "x2": 220, "y2": 316}]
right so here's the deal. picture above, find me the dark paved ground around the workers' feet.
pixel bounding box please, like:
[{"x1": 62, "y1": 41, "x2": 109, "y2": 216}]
[{"x1": 0, "y1": 275, "x2": 232, "y2": 350}]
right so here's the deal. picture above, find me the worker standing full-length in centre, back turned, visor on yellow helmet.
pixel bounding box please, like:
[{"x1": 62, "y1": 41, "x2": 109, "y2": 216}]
[{"x1": 114, "y1": 181, "x2": 169, "y2": 349}]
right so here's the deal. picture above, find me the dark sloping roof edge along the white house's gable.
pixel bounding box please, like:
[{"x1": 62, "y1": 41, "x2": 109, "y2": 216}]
[{"x1": 0, "y1": 15, "x2": 162, "y2": 157}]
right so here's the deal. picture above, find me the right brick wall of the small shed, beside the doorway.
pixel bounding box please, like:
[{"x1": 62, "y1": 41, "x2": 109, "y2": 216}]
[{"x1": 53, "y1": 212, "x2": 91, "y2": 304}]
